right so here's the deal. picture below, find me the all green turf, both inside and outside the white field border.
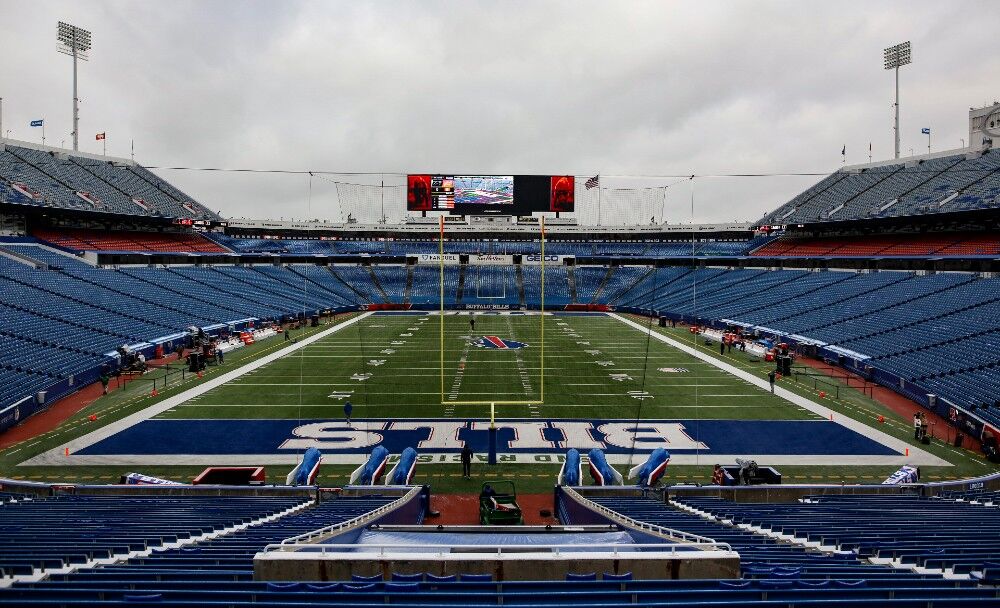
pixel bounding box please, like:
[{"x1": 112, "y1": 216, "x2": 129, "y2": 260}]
[{"x1": 0, "y1": 315, "x2": 996, "y2": 492}]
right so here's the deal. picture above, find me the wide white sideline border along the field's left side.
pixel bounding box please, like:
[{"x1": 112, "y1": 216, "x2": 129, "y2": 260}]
[{"x1": 17, "y1": 312, "x2": 372, "y2": 466}]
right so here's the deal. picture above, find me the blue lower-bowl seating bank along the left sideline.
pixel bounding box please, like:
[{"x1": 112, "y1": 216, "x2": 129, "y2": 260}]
[{"x1": 0, "y1": 243, "x2": 382, "y2": 407}]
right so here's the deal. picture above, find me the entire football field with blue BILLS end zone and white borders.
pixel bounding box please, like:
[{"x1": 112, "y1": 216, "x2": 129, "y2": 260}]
[{"x1": 13, "y1": 312, "x2": 949, "y2": 482}]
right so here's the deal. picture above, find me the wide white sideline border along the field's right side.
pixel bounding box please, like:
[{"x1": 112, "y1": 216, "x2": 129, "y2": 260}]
[{"x1": 608, "y1": 313, "x2": 952, "y2": 467}]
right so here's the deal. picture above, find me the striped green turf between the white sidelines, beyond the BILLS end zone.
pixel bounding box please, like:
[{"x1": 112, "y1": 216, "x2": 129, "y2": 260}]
[{"x1": 161, "y1": 315, "x2": 815, "y2": 420}]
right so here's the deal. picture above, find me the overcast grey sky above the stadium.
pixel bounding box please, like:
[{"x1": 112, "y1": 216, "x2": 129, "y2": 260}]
[{"x1": 0, "y1": 0, "x2": 1000, "y2": 223}]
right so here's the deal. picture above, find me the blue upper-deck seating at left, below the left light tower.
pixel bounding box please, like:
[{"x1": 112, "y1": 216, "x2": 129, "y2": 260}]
[{"x1": 0, "y1": 145, "x2": 220, "y2": 220}]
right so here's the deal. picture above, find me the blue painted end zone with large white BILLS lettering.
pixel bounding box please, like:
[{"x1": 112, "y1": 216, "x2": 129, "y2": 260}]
[{"x1": 75, "y1": 419, "x2": 899, "y2": 456}]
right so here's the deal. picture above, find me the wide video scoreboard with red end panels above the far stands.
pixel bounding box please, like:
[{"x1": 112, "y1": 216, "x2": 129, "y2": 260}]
[{"x1": 406, "y1": 175, "x2": 575, "y2": 215}]
